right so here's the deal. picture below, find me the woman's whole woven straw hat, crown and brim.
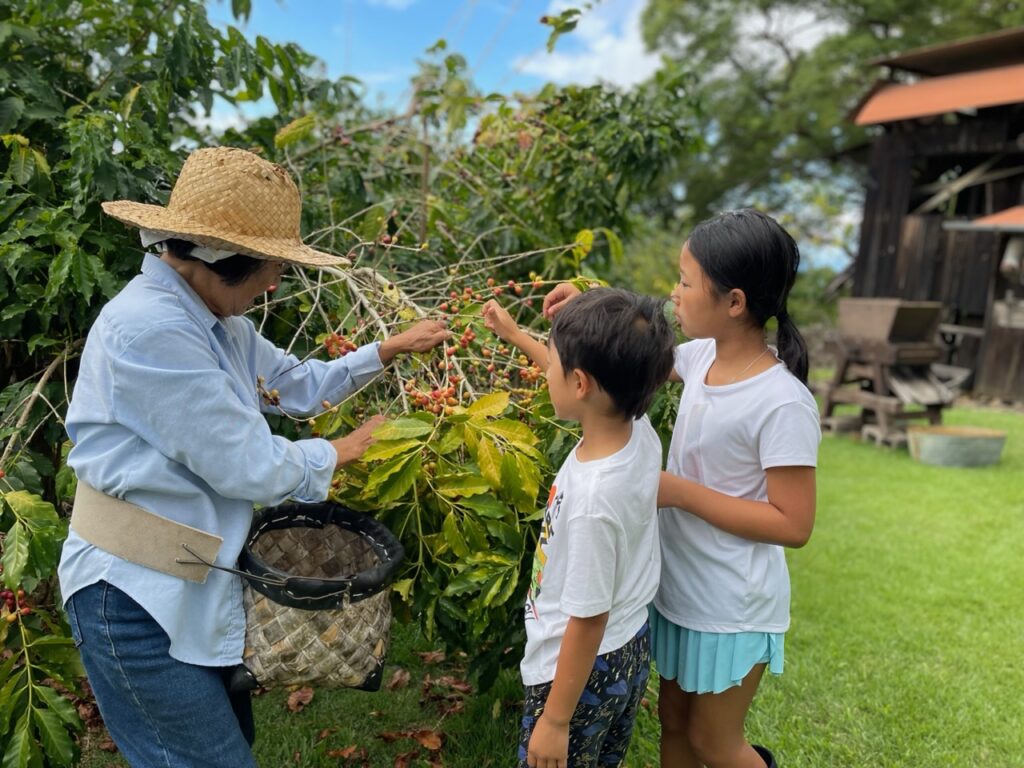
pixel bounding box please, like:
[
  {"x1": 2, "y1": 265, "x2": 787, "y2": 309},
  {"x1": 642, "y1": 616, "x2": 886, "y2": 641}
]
[{"x1": 103, "y1": 146, "x2": 349, "y2": 266}]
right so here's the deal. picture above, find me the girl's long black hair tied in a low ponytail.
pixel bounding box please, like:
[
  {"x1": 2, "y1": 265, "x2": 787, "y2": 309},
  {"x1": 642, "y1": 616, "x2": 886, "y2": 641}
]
[{"x1": 687, "y1": 208, "x2": 808, "y2": 384}]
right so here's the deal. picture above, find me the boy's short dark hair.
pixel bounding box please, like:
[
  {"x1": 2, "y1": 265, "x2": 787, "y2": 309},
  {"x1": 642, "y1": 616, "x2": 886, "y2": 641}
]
[{"x1": 551, "y1": 288, "x2": 676, "y2": 419}]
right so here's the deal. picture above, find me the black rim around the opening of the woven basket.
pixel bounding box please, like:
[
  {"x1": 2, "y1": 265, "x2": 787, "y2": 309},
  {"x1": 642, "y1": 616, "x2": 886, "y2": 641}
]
[{"x1": 239, "y1": 502, "x2": 406, "y2": 610}]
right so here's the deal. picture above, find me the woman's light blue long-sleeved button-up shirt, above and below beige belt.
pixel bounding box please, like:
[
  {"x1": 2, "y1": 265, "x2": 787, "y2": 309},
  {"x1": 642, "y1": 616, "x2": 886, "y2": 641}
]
[{"x1": 57, "y1": 255, "x2": 382, "y2": 667}]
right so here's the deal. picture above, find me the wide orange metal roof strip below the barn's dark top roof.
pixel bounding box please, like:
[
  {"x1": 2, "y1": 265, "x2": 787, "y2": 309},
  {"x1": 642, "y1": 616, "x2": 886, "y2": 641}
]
[{"x1": 854, "y1": 63, "x2": 1024, "y2": 125}]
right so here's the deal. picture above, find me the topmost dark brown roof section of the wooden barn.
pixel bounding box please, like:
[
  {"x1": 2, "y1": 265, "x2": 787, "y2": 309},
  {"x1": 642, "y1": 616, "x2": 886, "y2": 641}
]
[{"x1": 870, "y1": 27, "x2": 1024, "y2": 77}]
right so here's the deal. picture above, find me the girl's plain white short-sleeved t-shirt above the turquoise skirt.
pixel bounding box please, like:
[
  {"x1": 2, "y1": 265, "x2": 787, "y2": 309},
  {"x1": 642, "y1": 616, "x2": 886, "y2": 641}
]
[{"x1": 654, "y1": 339, "x2": 821, "y2": 633}]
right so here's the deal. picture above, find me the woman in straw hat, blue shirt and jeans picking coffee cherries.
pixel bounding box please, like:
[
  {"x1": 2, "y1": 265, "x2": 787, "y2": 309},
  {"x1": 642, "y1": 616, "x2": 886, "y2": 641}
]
[{"x1": 58, "y1": 147, "x2": 449, "y2": 768}]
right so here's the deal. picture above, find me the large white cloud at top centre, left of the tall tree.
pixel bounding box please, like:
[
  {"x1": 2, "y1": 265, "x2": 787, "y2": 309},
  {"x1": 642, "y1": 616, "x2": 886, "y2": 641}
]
[{"x1": 513, "y1": 0, "x2": 660, "y2": 87}]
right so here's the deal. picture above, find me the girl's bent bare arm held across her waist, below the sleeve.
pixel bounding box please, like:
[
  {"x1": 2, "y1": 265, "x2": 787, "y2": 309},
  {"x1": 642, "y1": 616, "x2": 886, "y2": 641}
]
[{"x1": 657, "y1": 467, "x2": 815, "y2": 547}]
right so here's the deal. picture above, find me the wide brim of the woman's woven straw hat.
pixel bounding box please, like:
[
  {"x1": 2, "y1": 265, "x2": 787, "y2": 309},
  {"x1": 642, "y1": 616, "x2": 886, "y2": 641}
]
[{"x1": 102, "y1": 200, "x2": 351, "y2": 266}]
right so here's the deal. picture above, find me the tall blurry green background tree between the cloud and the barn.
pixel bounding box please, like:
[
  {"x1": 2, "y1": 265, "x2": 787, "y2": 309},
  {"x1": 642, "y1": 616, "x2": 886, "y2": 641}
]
[{"x1": 643, "y1": 0, "x2": 1024, "y2": 255}]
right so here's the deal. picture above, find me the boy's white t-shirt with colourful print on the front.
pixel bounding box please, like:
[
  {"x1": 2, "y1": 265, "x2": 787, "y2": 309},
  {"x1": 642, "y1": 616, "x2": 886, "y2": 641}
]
[{"x1": 520, "y1": 416, "x2": 662, "y2": 685}]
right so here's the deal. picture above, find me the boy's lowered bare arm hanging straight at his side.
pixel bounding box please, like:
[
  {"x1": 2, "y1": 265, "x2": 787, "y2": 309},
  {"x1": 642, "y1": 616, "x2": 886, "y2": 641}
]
[{"x1": 526, "y1": 611, "x2": 608, "y2": 768}]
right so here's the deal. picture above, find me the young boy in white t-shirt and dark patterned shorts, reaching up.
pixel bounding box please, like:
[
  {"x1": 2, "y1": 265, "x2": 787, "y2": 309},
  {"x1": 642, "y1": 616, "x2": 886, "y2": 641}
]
[{"x1": 483, "y1": 289, "x2": 675, "y2": 768}]
